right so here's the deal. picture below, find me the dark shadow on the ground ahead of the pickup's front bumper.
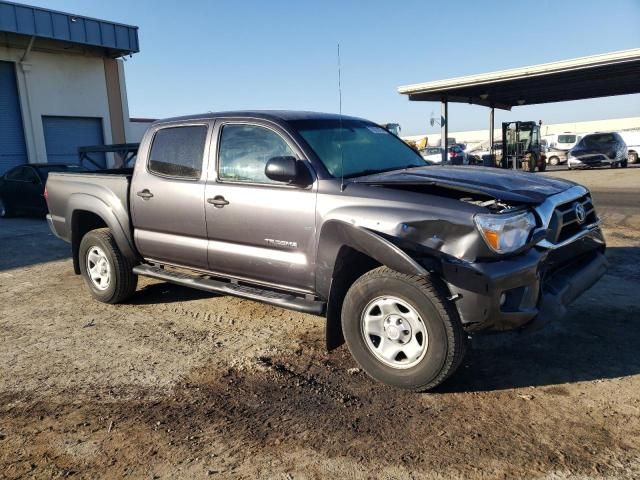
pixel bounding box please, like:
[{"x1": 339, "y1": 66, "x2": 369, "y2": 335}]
[{"x1": 437, "y1": 247, "x2": 640, "y2": 393}]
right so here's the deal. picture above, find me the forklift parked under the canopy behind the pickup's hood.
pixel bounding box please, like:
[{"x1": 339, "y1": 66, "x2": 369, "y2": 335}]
[{"x1": 500, "y1": 122, "x2": 547, "y2": 172}]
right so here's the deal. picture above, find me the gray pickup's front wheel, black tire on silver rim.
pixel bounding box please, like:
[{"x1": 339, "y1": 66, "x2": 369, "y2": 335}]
[{"x1": 342, "y1": 267, "x2": 467, "y2": 392}]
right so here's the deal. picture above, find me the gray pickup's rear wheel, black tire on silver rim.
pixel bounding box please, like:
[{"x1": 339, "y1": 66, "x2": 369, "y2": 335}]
[{"x1": 78, "y1": 228, "x2": 138, "y2": 304}]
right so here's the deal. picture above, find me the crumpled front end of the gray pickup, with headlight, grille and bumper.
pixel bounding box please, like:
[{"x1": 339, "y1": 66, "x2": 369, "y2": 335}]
[{"x1": 358, "y1": 178, "x2": 607, "y2": 331}]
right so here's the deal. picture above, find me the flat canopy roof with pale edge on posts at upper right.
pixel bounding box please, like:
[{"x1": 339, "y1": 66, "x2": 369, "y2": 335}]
[{"x1": 398, "y1": 48, "x2": 640, "y2": 110}]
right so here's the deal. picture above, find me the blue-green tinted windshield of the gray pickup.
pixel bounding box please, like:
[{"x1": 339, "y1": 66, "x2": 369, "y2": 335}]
[{"x1": 291, "y1": 119, "x2": 427, "y2": 178}]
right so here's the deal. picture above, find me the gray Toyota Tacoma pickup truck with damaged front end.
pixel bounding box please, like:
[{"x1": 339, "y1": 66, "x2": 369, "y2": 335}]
[{"x1": 45, "y1": 111, "x2": 607, "y2": 391}]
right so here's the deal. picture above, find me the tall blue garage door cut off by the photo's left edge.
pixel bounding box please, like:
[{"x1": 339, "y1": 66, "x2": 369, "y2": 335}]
[{"x1": 0, "y1": 62, "x2": 27, "y2": 174}]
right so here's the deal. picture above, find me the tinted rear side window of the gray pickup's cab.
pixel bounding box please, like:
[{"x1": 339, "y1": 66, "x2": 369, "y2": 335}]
[{"x1": 149, "y1": 125, "x2": 207, "y2": 179}]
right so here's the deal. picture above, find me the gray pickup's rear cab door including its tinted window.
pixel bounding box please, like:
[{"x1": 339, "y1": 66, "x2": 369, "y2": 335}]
[{"x1": 130, "y1": 122, "x2": 209, "y2": 269}]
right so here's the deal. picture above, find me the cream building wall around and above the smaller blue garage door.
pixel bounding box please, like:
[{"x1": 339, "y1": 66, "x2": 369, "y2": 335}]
[{"x1": 0, "y1": 46, "x2": 112, "y2": 163}]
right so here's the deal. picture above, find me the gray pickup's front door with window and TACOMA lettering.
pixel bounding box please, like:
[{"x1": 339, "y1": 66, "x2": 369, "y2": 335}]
[{"x1": 205, "y1": 121, "x2": 316, "y2": 290}]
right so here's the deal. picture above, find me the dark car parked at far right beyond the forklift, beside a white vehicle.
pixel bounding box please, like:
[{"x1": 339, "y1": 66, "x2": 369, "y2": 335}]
[{"x1": 567, "y1": 132, "x2": 629, "y2": 170}]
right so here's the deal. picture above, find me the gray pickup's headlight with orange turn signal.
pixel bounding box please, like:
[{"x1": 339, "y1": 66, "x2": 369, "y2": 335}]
[{"x1": 474, "y1": 212, "x2": 536, "y2": 253}]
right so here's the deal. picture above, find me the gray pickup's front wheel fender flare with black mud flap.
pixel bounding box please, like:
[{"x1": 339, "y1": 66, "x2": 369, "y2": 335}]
[{"x1": 316, "y1": 220, "x2": 428, "y2": 350}]
